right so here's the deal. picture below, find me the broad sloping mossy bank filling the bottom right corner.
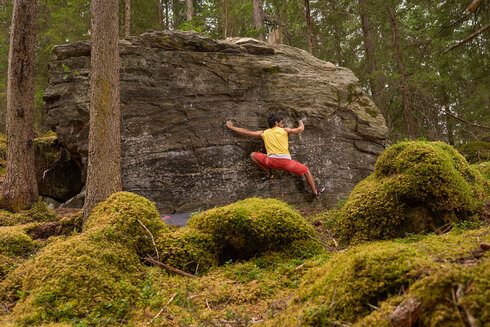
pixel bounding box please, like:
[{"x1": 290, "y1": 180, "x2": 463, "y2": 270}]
[{"x1": 266, "y1": 228, "x2": 490, "y2": 326}]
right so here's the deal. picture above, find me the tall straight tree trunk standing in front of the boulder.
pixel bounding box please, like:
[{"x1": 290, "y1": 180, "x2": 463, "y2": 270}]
[{"x1": 83, "y1": 0, "x2": 122, "y2": 220}]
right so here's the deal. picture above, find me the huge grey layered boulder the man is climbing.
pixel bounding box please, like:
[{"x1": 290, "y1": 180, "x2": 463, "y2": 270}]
[{"x1": 44, "y1": 31, "x2": 387, "y2": 213}]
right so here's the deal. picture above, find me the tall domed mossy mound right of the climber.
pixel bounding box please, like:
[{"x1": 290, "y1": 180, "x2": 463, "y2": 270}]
[{"x1": 338, "y1": 141, "x2": 488, "y2": 243}]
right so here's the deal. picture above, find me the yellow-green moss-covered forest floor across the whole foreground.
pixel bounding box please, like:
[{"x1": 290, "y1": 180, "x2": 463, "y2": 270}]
[{"x1": 0, "y1": 142, "x2": 490, "y2": 327}]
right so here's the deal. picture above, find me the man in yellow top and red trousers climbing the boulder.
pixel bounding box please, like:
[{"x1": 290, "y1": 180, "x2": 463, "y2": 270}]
[{"x1": 226, "y1": 114, "x2": 325, "y2": 199}]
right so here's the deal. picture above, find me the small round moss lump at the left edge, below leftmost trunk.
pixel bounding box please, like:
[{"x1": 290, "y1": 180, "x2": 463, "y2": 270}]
[{"x1": 0, "y1": 226, "x2": 34, "y2": 256}]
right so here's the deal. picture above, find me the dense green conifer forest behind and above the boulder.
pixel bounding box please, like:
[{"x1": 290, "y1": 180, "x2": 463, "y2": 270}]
[{"x1": 0, "y1": 0, "x2": 490, "y2": 145}]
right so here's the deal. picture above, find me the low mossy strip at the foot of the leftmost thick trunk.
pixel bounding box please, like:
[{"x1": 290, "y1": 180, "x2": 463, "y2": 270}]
[{"x1": 0, "y1": 201, "x2": 59, "y2": 226}]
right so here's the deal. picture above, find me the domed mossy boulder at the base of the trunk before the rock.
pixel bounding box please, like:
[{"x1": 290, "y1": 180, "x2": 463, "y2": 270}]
[{"x1": 83, "y1": 192, "x2": 170, "y2": 257}]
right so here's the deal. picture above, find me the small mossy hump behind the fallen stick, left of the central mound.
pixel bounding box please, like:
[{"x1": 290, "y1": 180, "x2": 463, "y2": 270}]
[{"x1": 156, "y1": 227, "x2": 218, "y2": 274}]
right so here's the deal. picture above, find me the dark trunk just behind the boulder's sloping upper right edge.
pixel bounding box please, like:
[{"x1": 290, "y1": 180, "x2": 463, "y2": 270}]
[{"x1": 359, "y1": 0, "x2": 388, "y2": 118}]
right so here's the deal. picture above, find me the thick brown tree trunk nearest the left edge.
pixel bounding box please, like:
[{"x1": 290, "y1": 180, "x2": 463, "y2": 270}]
[{"x1": 0, "y1": 0, "x2": 37, "y2": 211}]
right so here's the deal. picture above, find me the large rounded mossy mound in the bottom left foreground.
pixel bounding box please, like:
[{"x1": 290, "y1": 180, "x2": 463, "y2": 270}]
[{"x1": 0, "y1": 229, "x2": 144, "y2": 325}]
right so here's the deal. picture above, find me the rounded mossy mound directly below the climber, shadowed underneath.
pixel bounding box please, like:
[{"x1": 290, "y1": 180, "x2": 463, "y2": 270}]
[{"x1": 188, "y1": 198, "x2": 318, "y2": 261}]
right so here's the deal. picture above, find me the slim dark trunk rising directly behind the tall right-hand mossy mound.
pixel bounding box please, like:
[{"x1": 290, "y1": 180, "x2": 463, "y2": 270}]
[{"x1": 388, "y1": 7, "x2": 415, "y2": 139}]
